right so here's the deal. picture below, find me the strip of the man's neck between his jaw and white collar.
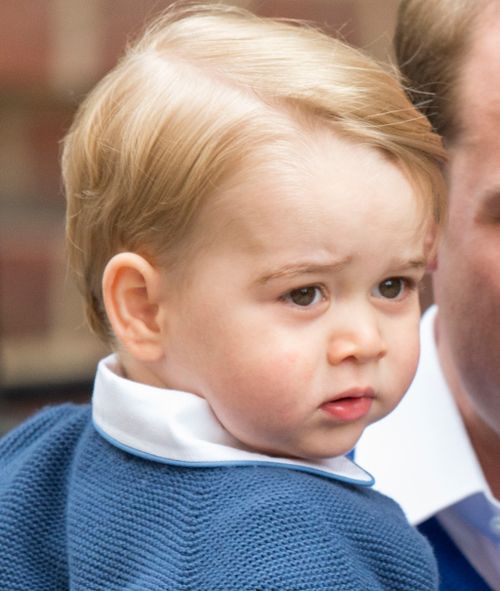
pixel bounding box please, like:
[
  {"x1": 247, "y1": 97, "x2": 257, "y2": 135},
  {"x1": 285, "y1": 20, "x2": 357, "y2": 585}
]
[{"x1": 435, "y1": 316, "x2": 500, "y2": 500}]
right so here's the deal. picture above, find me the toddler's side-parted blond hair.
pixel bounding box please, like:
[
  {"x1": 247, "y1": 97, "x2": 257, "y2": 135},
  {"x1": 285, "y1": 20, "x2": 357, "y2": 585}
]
[{"x1": 63, "y1": 4, "x2": 444, "y2": 341}]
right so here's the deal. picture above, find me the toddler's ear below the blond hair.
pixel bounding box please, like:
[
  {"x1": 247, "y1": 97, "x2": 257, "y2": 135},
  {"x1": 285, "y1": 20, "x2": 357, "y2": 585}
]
[{"x1": 102, "y1": 252, "x2": 164, "y2": 362}]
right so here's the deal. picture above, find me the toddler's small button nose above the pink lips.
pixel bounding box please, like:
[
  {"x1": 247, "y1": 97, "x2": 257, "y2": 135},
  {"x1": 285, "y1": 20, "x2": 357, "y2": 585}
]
[{"x1": 327, "y1": 313, "x2": 387, "y2": 365}]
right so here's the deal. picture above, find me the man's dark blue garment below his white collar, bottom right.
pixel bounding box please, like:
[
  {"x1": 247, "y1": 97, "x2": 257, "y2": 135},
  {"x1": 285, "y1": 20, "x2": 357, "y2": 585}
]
[{"x1": 418, "y1": 517, "x2": 491, "y2": 591}]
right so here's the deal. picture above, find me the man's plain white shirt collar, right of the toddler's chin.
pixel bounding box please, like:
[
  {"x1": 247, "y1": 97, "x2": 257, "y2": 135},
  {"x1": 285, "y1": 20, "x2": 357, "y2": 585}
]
[{"x1": 356, "y1": 307, "x2": 497, "y2": 523}]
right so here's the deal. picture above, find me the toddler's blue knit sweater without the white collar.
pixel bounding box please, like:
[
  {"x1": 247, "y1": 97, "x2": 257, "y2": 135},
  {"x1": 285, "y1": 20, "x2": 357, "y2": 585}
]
[{"x1": 0, "y1": 405, "x2": 437, "y2": 591}]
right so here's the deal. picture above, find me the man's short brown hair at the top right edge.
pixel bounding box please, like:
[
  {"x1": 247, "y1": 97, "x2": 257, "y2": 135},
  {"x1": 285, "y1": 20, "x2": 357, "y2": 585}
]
[{"x1": 394, "y1": 0, "x2": 486, "y2": 143}]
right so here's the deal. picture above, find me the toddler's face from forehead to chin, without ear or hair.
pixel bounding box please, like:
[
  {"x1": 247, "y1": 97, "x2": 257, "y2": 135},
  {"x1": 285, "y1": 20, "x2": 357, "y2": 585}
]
[{"x1": 157, "y1": 136, "x2": 425, "y2": 458}]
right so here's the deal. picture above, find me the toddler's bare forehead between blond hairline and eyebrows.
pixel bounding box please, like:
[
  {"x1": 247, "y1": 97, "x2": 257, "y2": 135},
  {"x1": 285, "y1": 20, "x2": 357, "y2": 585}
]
[{"x1": 166, "y1": 136, "x2": 429, "y2": 286}]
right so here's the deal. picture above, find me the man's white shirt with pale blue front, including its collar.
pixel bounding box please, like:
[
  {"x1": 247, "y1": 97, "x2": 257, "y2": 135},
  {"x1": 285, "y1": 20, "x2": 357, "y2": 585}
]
[{"x1": 356, "y1": 306, "x2": 500, "y2": 591}]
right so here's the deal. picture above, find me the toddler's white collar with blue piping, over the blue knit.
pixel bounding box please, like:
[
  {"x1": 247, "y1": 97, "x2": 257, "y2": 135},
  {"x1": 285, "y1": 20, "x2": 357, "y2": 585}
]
[{"x1": 92, "y1": 355, "x2": 374, "y2": 486}]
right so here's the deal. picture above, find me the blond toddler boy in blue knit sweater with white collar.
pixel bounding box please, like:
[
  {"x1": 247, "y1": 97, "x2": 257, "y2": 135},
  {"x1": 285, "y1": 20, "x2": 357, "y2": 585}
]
[{"x1": 0, "y1": 5, "x2": 443, "y2": 591}]
